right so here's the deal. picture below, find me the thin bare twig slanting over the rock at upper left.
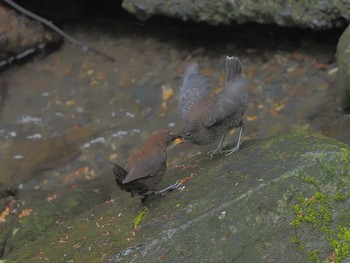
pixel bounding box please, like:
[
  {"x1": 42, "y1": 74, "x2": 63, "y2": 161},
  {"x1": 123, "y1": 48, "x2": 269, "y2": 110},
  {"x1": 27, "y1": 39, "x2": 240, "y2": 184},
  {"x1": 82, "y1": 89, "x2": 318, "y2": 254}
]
[{"x1": 4, "y1": 0, "x2": 115, "y2": 61}]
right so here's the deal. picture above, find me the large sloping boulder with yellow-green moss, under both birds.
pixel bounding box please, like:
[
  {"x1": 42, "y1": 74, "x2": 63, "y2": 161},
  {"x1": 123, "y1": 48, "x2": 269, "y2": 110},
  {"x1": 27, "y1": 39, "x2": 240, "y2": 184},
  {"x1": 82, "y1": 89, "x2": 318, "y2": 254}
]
[{"x1": 4, "y1": 133, "x2": 350, "y2": 263}]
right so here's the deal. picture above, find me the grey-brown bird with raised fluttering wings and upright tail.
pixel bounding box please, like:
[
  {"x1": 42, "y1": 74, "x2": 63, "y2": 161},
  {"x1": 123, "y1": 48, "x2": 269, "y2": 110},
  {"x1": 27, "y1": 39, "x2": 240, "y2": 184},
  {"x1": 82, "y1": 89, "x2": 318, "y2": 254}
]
[{"x1": 179, "y1": 56, "x2": 247, "y2": 157}]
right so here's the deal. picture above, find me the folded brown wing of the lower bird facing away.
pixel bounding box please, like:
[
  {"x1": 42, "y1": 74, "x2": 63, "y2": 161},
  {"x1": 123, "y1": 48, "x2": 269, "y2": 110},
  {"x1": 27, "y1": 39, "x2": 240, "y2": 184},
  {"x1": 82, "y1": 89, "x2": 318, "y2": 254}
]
[{"x1": 123, "y1": 151, "x2": 166, "y2": 184}]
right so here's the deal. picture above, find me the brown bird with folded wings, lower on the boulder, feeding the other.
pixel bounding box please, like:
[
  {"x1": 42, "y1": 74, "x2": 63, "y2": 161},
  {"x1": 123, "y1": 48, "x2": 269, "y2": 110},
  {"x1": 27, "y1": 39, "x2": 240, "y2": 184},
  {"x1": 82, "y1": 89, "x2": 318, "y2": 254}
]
[{"x1": 113, "y1": 130, "x2": 179, "y2": 202}]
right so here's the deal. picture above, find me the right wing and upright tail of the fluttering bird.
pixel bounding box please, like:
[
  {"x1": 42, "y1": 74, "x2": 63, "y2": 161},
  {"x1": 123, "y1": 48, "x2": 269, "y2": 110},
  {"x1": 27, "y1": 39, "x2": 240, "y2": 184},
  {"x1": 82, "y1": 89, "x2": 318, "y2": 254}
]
[{"x1": 204, "y1": 57, "x2": 247, "y2": 127}]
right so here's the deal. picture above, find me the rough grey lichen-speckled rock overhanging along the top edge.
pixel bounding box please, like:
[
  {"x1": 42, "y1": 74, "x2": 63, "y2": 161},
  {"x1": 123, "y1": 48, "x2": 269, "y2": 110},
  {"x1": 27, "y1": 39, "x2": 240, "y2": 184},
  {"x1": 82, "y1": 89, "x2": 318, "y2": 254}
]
[{"x1": 122, "y1": 0, "x2": 350, "y2": 29}]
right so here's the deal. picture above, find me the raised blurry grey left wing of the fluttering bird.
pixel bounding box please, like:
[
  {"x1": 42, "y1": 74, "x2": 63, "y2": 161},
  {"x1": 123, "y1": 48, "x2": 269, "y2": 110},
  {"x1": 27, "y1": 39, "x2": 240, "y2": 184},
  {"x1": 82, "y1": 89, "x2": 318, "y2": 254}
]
[{"x1": 179, "y1": 63, "x2": 210, "y2": 119}]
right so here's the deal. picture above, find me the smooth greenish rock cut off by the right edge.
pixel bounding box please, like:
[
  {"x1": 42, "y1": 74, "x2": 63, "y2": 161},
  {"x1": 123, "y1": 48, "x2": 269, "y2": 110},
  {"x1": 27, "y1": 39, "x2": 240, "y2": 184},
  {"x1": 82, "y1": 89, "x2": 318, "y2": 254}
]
[{"x1": 337, "y1": 26, "x2": 350, "y2": 113}]
